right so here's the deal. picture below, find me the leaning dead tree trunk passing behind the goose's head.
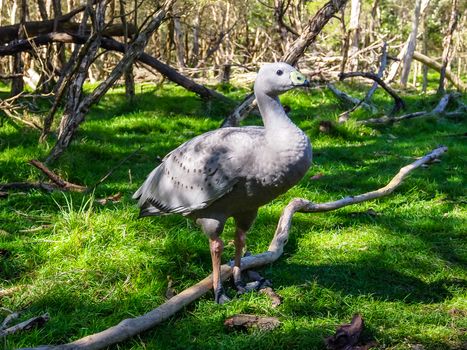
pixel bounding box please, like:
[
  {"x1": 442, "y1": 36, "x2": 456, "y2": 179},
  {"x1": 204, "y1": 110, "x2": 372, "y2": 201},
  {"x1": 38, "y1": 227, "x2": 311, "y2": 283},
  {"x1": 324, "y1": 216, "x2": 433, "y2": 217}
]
[{"x1": 222, "y1": 0, "x2": 347, "y2": 127}]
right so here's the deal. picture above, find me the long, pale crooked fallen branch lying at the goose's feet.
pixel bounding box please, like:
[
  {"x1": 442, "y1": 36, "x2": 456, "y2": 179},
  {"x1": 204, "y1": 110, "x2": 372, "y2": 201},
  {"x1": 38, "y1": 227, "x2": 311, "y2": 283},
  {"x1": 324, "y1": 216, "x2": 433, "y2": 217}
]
[{"x1": 18, "y1": 146, "x2": 447, "y2": 350}]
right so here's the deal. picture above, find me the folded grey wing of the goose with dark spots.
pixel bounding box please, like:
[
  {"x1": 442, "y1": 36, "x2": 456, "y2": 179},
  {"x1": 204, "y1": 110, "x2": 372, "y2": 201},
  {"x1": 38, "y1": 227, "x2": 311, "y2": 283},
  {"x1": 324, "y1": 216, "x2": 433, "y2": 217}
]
[{"x1": 133, "y1": 128, "x2": 256, "y2": 216}]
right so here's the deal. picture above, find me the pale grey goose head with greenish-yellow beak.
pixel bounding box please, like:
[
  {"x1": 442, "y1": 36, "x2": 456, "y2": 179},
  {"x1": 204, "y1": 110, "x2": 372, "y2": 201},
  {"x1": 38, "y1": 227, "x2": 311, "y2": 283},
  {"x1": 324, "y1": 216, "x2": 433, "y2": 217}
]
[{"x1": 255, "y1": 62, "x2": 310, "y2": 97}]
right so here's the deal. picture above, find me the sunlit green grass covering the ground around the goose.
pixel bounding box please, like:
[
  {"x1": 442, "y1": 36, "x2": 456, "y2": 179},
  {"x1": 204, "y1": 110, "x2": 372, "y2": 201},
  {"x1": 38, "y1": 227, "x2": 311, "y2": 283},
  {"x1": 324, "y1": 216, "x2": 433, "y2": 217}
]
[{"x1": 0, "y1": 80, "x2": 467, "y2": 349}]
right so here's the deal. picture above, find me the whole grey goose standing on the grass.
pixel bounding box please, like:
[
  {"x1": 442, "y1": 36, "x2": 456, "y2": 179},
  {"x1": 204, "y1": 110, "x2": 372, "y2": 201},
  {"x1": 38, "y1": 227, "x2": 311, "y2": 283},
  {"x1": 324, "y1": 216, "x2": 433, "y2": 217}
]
[{"x1": 133, "y1": 63, "x2": 311, "y2": 302}]
